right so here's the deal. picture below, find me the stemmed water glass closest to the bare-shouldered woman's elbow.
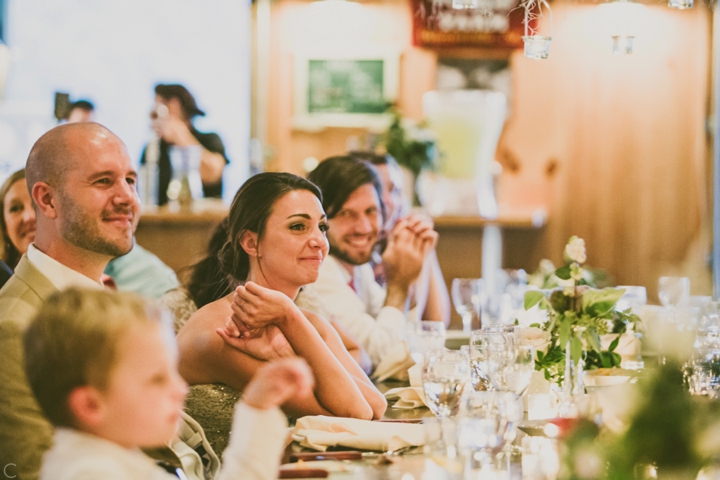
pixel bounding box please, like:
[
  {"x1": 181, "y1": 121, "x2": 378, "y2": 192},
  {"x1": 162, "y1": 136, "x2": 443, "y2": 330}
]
[{"x1": 422, "y1": 349, "x2": 470, "y2": 418}]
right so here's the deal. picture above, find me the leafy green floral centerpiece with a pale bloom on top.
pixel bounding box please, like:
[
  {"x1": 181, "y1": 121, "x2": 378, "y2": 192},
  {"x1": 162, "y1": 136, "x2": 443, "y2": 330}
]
[{"x1": 525, "y1": 236, "x2": 640, "y2": 384}]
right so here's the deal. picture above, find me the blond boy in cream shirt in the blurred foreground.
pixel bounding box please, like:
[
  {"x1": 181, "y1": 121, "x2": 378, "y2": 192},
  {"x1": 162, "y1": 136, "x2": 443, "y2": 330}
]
[{"x1": 25, "y1": 289, "x2": 312, "y2": 480}]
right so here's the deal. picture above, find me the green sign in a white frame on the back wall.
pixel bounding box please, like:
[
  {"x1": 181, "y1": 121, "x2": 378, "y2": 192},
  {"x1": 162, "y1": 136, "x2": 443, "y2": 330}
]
[{"x1": 293, "y1": 50, "x2": 400, "y2": 130}]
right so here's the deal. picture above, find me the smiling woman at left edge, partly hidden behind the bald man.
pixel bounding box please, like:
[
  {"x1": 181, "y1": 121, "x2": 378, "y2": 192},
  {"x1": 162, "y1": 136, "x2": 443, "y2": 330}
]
[{"x1": 0, "y1": 168, "x2": 35, "y2": 287}]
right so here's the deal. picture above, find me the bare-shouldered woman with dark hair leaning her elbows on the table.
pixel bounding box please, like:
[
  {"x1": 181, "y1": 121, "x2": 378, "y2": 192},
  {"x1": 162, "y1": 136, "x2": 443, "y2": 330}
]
[{"x1": 177, "y1": 173, "x2": 387, "y2": 452}]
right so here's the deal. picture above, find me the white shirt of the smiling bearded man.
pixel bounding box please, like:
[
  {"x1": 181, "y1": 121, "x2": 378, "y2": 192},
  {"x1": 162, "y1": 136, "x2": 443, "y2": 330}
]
[{"x1": 309, "y1": 255, "x2": 408, "y2": 365}]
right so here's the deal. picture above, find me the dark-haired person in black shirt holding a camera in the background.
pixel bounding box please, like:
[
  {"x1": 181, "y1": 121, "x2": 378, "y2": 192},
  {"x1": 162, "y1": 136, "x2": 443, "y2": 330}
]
[{"x1": 140, "y1": 84, "x2": 230, "y2": 205}]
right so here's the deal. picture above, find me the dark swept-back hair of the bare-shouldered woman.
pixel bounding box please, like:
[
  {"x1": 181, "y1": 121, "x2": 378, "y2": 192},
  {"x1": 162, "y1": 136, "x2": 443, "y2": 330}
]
[{"x1": 187, "y1": 172, "x2": 322, "y2": 308}]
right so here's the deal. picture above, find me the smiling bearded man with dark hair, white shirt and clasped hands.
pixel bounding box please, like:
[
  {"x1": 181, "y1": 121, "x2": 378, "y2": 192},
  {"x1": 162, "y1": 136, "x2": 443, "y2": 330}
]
[{"x1": 308, "y1": 156, "x2": 437, "y2": 366}]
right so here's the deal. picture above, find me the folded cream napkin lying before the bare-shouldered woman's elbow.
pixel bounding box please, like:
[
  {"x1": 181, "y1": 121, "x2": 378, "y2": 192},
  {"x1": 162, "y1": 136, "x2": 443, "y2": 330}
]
[{"x1": 292, "y1": 415, "x2": 425, "y2": 452}]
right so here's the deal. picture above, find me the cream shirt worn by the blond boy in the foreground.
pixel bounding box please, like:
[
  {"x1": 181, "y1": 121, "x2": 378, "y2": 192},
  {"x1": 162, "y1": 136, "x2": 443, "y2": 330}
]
[{"x1": 40, "y1": 403, "x2": 287, "y2": 480}]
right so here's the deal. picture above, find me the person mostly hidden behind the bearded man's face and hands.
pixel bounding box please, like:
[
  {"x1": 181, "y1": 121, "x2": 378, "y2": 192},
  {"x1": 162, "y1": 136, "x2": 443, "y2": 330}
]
[{"x1": 348, "y1": 151, "x2": 450, "y2": 326}]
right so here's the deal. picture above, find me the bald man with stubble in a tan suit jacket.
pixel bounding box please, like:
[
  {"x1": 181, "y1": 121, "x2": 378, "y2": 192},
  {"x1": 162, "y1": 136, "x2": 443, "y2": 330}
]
[{"x1": 0, "y1": 123, "x2": 139, "y2": 480}]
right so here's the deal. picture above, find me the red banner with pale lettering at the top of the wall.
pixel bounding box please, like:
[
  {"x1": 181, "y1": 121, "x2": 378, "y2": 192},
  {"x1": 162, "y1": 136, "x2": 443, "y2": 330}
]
[{"x1": 410, "y1": 0, "x2": 534, "y2": 48}]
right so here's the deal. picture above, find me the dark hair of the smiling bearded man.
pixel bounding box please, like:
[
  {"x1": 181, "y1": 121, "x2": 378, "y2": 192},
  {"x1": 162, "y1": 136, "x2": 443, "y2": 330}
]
[{"x1": 308, "y1": 155, "x2": 385, "y2": 219}]
